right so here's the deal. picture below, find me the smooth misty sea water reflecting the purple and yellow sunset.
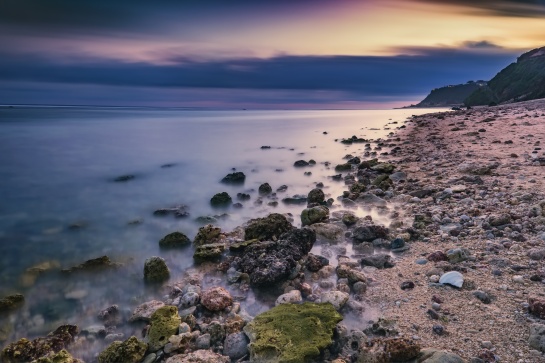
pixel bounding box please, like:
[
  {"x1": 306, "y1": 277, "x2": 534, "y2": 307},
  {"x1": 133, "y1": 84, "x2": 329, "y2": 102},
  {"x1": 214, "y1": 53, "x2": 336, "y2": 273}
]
[{"x1": 0, "y1": 108, "x2": 436, "y2": 360}]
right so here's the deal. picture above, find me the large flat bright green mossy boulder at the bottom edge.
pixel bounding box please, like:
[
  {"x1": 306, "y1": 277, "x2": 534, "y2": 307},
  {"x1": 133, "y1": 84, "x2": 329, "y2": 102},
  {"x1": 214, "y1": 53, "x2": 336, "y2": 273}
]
[{"x1": 244, "y1": 303, "x2": 343, "y2": 363}]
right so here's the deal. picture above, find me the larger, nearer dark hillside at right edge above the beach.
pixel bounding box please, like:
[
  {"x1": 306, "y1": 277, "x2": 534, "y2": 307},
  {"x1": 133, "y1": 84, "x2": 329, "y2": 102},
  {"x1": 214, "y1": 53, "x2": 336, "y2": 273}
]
[{"x1": 464, "y1": 47, "x2": 545, "y2": 106}]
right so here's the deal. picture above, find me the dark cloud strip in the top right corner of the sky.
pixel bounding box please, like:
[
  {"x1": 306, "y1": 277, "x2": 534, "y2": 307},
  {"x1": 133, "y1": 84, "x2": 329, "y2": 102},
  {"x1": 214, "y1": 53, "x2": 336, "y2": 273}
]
[{"x1": 417, "y1": 0, "x2": 545, "y2": 18}]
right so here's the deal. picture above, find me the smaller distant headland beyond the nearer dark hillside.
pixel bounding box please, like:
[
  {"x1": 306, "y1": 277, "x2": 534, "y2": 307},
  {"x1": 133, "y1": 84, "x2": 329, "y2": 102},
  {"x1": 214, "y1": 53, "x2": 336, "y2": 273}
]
[{"x1": 412, "y1": 81, "x2": 486, "y2": 107}]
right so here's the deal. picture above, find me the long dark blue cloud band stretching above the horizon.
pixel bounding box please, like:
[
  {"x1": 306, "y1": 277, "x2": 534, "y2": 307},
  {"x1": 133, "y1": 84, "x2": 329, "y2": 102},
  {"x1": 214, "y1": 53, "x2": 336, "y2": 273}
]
[{"x1": 0, "y1": 49, "x2": 518, "y2": 101}]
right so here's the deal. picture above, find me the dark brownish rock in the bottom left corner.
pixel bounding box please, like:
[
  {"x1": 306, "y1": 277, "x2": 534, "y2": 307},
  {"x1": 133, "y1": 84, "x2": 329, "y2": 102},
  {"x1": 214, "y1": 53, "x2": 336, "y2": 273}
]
[{"x1": 0, "y1": 325, "x2": 79, "y2": 363}]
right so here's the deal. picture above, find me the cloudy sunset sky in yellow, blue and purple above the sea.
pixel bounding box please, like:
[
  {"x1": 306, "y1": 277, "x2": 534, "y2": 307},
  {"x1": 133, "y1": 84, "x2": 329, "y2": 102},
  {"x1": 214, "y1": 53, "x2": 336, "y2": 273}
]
[{"x1": 0, "y1": 0, "x2": 545, "y2": 109}]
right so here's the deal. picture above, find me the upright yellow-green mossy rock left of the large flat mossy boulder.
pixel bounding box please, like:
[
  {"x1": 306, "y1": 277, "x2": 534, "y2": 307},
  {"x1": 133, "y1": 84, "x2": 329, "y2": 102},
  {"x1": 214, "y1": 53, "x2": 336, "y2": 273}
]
[{"x1": 147, "y1": 305, "x2": 182, "y2": 352}]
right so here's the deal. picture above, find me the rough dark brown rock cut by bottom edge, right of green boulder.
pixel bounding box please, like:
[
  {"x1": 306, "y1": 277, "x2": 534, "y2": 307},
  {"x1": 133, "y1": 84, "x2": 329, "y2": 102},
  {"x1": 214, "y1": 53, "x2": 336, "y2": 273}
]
[{"x1": 356, "y1": 338, "x2": 420, "y2": 363}]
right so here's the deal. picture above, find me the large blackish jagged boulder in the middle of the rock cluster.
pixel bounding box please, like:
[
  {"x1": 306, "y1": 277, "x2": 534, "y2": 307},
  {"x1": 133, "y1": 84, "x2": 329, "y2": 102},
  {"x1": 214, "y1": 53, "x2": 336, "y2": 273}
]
[{"x1": 237, "y1": 228, "x2": 316, "y2": 285}]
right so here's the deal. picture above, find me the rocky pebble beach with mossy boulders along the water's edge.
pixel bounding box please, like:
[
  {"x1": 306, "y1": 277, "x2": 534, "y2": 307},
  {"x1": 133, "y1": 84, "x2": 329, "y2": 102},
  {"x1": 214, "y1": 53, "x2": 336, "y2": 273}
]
[{"x1": 0, "y1": 101, "x2": 545, "y2": 363}]
